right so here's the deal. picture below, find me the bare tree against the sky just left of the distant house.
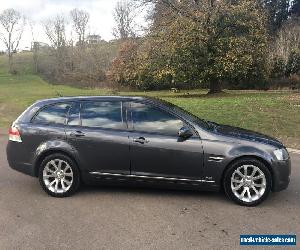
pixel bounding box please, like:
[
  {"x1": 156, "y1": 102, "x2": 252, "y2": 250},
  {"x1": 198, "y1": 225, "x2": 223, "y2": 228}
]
[{"x1": 71, "y1": 9, "x2": 90, "y2": 45}]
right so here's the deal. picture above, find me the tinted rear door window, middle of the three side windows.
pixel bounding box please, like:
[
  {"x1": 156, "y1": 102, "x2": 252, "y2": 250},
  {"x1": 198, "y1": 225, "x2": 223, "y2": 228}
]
[{"x1": 80, "y1": 102, "x2": 124, "y2": 129}]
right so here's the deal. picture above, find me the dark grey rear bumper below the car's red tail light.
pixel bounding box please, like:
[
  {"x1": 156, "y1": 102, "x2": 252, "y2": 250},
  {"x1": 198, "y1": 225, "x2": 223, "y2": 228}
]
[{"x1": 6, "y1": 141, "x2": 36, "y2": 176}]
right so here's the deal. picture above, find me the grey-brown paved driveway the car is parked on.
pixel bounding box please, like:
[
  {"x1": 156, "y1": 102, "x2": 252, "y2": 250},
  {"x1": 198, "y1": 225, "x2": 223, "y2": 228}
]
[{"x1": 0, "y1": 136, "x2": 300, "y2": 250}]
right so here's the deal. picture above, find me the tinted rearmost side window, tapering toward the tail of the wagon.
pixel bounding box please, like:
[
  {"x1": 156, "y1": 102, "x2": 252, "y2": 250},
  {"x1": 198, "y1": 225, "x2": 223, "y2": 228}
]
[{"x1": 33, "y1": 103, "x2": 71, "y2": 124}]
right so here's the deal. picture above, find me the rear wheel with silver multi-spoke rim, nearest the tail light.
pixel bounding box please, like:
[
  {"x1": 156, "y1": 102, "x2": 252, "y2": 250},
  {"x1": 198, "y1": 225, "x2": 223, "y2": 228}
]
[{"x1": 39, "y1": 153, "x2": 80, "y2": 198}]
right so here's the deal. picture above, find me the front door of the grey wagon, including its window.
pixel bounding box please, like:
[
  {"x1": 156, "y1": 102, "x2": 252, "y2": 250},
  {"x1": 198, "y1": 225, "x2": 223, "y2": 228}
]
[{"x1": 127, "y1": 102, "x2": 203, "y2": 180}]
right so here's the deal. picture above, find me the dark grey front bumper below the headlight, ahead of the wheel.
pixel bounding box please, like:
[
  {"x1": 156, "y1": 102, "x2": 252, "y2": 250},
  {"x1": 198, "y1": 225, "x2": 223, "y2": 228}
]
[{"x1": 272, "y1": 159, "x2": 291, "y2": 192}]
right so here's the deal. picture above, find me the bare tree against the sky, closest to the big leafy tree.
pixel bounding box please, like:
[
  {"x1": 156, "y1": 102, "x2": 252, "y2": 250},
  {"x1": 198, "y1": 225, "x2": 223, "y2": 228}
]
[{"x1": 113, "y1": 0, "x2": 136, "y2": 39}]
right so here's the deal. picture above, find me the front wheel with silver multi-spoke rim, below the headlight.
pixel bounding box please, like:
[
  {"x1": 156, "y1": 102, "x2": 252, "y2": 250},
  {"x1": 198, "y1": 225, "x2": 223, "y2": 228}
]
[{"x1": 223, "y1": 158, "x2": 272, "y2": 207}]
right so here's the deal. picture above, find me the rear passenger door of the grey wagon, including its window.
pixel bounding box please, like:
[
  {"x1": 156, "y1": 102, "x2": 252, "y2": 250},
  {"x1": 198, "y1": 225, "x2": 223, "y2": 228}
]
[{"x1": 66, "y1": 100, "x2": 130, "y2": 174}]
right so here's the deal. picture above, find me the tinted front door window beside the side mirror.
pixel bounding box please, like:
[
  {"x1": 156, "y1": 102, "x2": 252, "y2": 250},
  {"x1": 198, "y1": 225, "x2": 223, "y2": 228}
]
[{"x1": 131, "y1": 103, "x2": 184, "y2": 136}]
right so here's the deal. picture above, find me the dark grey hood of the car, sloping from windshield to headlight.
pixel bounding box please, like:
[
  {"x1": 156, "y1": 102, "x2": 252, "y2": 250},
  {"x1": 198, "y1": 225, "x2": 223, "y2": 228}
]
[{"x1": 212, "y1": 123, "x2": 283, "y2": 148}]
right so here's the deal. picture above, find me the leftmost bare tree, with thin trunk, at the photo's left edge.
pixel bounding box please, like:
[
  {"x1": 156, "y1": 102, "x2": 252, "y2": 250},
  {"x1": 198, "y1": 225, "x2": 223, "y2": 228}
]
[{"x1": 0, "y1": 9, "x2": 25, "y2": 72}]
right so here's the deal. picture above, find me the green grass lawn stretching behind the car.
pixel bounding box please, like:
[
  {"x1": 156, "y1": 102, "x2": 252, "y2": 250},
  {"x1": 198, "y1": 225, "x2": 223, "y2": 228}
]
[{"x1": 0, "y1": 62, "x2": 300, "y2": 149}]
